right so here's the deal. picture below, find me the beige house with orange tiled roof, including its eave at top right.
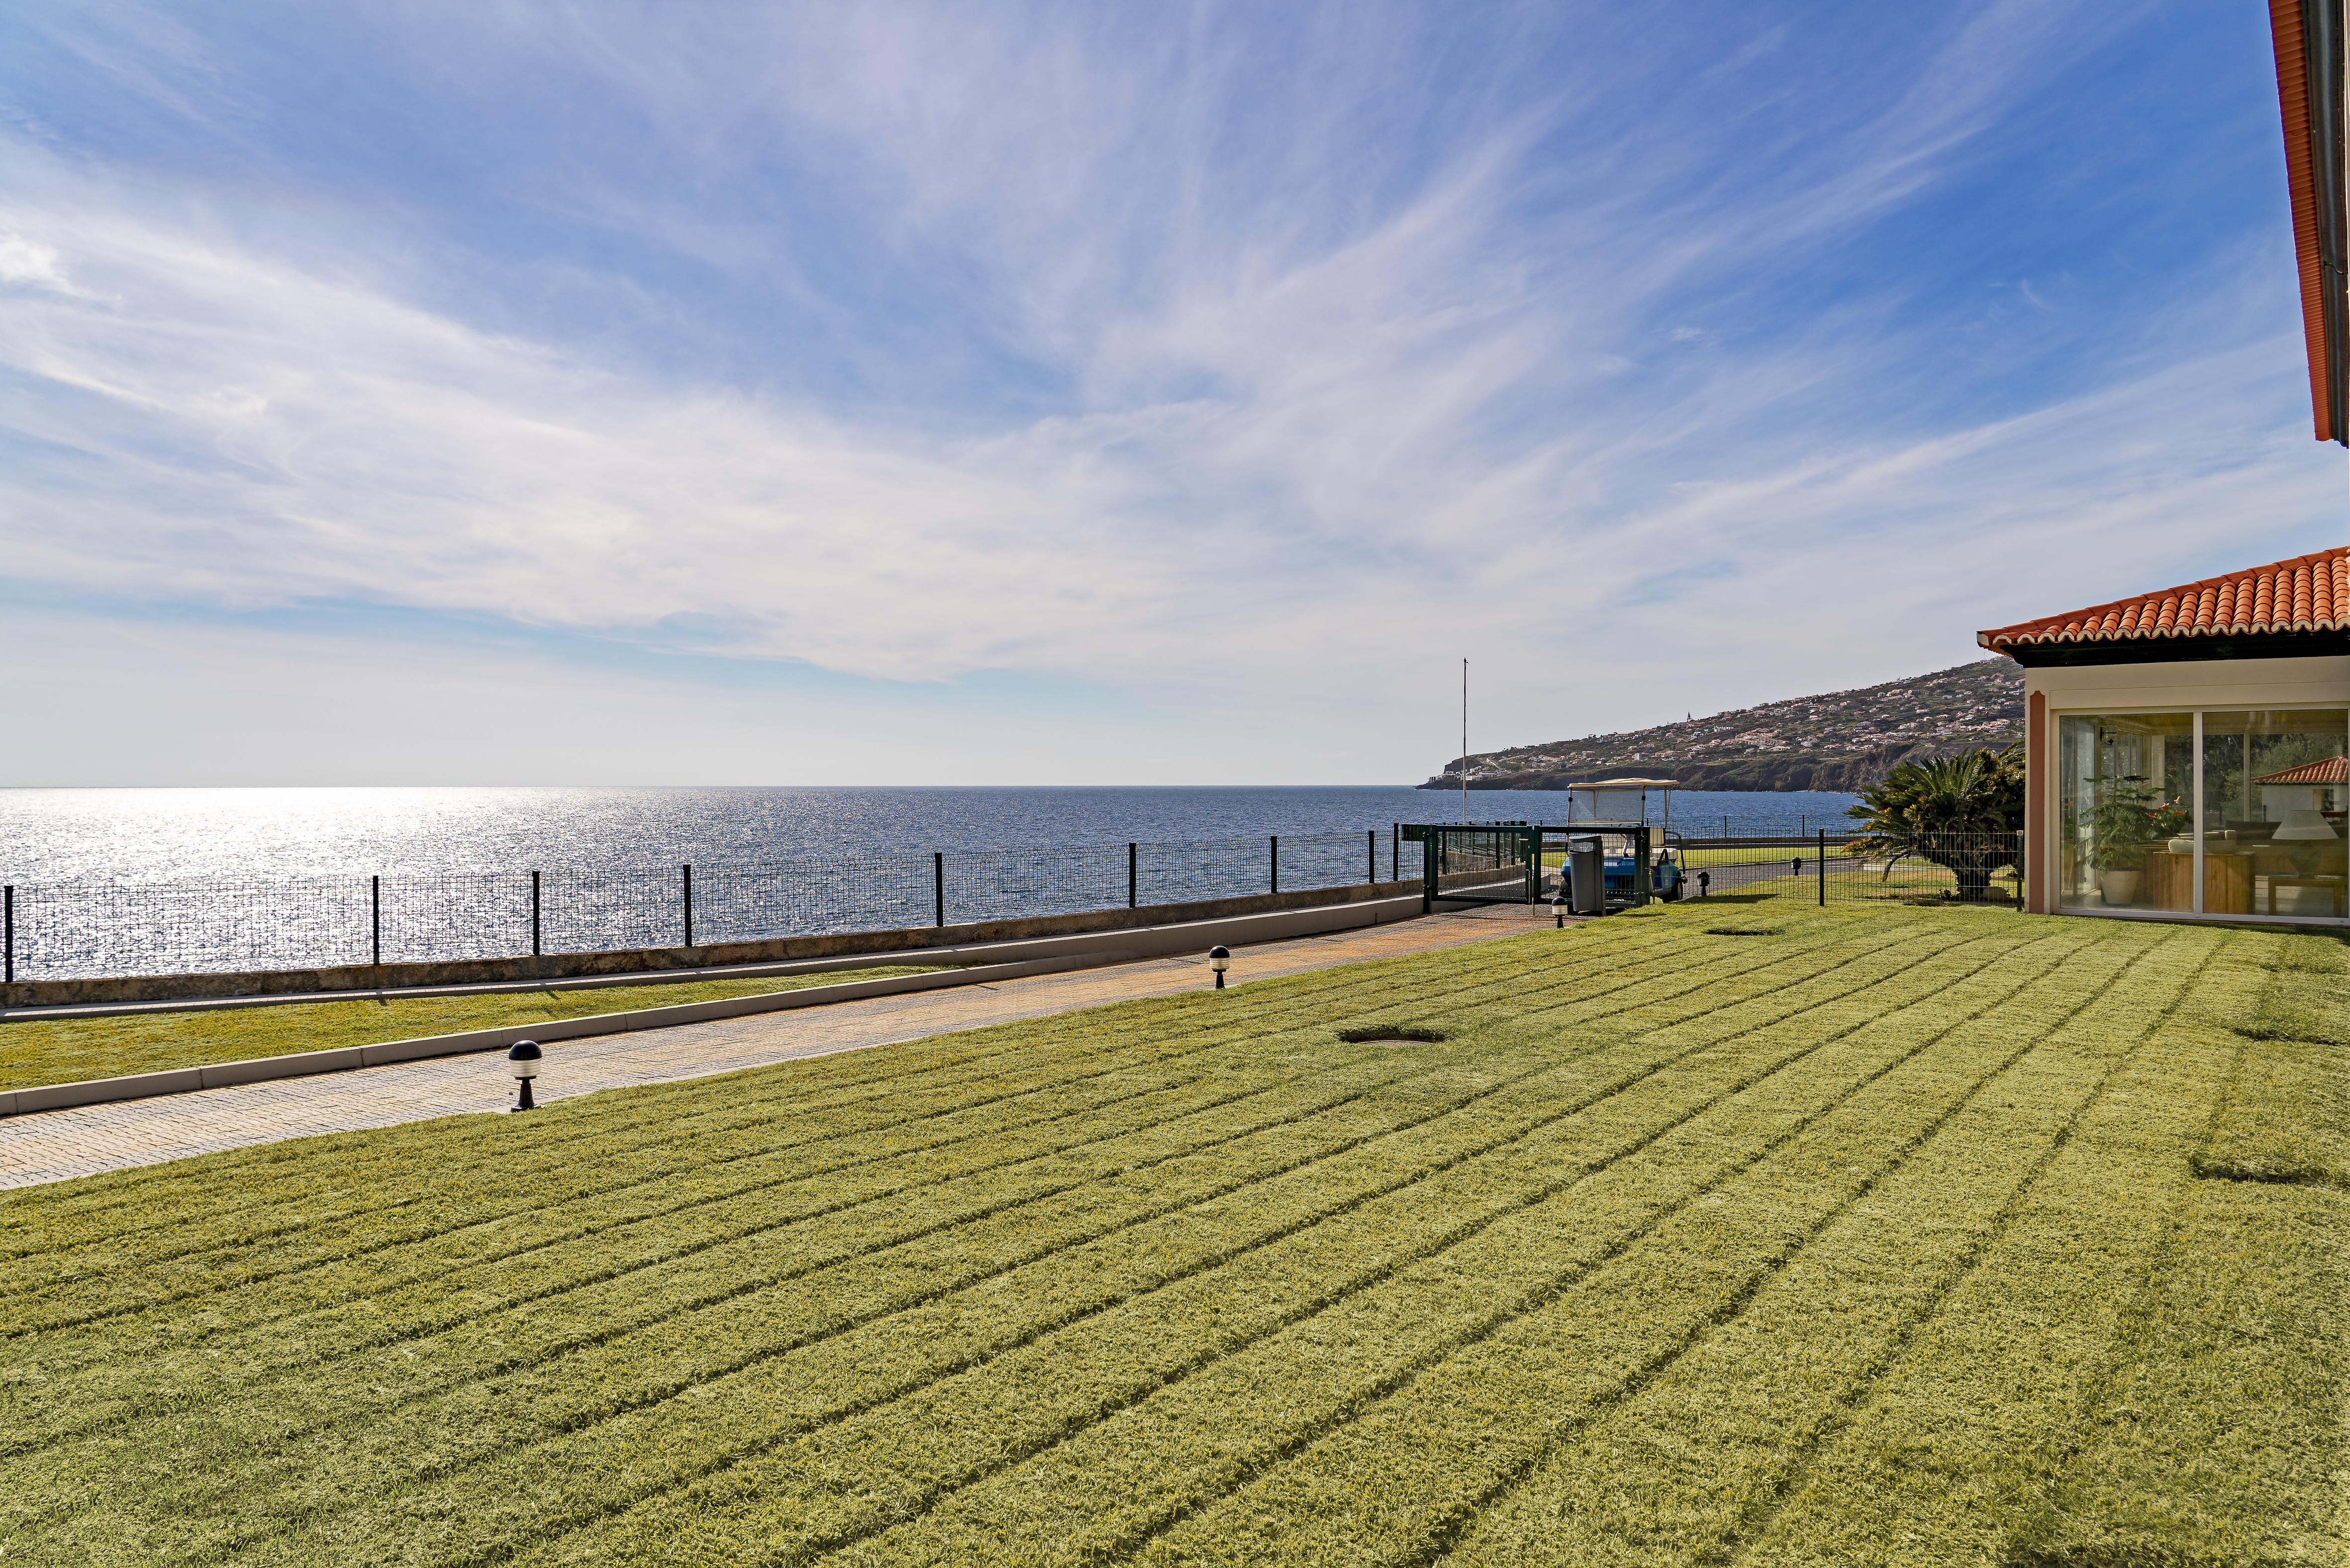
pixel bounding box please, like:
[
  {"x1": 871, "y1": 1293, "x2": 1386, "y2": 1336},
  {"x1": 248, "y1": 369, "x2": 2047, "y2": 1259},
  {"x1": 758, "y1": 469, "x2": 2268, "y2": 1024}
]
[{"x1": 1976, "y1": 0, "x2": 2350, "y2": 926}]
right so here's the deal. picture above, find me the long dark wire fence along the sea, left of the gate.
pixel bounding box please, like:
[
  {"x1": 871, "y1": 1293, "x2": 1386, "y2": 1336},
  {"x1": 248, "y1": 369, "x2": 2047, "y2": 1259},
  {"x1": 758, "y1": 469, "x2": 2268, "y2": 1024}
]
[{"x1": 0, "y1": 827, "x2": 1419, "y2": 980}]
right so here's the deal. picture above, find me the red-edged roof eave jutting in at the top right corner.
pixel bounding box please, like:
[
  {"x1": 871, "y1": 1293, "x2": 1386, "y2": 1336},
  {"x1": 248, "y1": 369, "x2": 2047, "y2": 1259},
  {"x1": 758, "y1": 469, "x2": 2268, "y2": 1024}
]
[{"x1": 2268, "y1": 0, "x2": 2350, "y2": 444}]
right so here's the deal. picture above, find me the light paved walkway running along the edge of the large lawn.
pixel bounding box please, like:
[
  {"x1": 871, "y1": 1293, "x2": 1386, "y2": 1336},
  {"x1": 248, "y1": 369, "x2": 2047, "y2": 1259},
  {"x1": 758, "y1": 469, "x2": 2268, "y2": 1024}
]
[{"x1": 0, "y1": 905, "x2": 1579, "y2": 1187}]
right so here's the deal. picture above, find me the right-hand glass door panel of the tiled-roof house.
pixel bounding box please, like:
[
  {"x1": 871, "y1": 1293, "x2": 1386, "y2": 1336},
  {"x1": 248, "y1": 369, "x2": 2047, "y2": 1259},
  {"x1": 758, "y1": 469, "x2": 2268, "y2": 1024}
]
[{"x1": 2202, "y1": 707, "x2": 2350, "y2": 919}]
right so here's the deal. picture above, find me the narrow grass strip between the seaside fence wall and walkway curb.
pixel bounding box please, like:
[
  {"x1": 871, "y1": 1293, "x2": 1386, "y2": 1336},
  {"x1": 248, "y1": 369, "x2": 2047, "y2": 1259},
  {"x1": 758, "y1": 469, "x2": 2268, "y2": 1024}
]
[{"x1": 0, "y1": 964, "x2": 952, "y2": 1088}]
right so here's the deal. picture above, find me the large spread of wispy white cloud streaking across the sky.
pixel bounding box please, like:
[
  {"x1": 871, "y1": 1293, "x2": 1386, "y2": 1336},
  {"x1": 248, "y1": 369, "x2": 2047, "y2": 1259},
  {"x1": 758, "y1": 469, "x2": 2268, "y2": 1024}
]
[{"x1": 0, "y1": 4, "x2": 2331, "y2": 778}]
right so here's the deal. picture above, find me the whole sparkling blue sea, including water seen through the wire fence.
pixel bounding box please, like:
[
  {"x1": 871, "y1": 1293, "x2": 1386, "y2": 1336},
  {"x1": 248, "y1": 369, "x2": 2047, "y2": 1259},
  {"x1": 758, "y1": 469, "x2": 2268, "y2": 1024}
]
[{"x1": 0, "y1": 785, "x2": 1852, "y2": 980}]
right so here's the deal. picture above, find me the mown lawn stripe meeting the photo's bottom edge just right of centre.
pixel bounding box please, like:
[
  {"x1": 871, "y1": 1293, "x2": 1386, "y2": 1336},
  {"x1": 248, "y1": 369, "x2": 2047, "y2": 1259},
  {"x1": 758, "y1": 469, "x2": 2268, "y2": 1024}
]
[{"x1": 1104, "y1": 931, "x2": 2180, "y2": 1564}]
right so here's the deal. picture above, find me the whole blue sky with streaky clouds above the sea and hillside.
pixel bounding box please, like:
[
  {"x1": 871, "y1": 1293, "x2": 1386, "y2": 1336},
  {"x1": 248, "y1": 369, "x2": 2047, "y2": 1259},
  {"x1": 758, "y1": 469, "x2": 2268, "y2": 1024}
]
[{"x1": 0, "y1": 0, "x2": 2346, "y2": 785}]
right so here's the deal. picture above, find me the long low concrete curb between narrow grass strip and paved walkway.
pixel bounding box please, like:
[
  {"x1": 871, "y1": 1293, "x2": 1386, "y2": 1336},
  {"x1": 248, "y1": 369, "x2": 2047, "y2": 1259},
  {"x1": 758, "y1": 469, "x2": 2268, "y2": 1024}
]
[{"x1": 0, "y1": 898, "x2": 1422, "y2": 1117}]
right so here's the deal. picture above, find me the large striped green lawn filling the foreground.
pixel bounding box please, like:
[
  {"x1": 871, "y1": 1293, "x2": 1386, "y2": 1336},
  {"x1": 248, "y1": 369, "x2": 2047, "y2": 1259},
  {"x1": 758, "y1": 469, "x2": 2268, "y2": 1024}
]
[{"x1": 0, "y1": 898, "x2": 2350, "y2": 1568}]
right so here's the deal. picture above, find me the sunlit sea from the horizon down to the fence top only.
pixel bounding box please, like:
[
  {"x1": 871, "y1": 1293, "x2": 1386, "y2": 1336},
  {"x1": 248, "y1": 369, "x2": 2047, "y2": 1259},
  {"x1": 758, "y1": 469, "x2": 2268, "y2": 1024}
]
[{"x1": 0, "y1": 785, "x2": 1854, "y2": 886}]
